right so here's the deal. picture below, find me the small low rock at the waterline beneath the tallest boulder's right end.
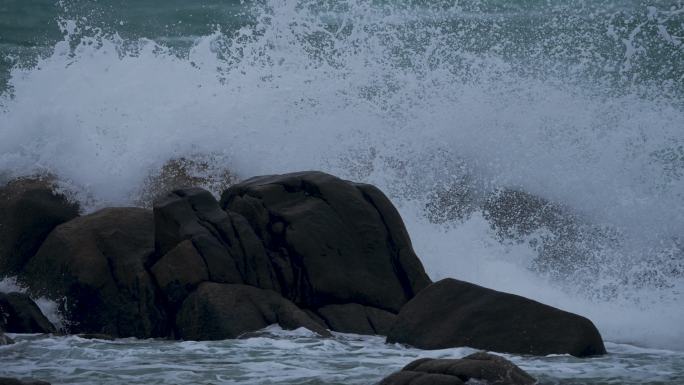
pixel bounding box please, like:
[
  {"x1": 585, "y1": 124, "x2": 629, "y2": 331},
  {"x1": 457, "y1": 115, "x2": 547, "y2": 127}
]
[{"x1": 316, "y1": 303, "x2": 397, "y2": 335}]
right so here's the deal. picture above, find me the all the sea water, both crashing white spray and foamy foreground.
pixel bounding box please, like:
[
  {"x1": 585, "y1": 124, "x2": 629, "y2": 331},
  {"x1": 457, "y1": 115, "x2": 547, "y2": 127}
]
[{"x1": 0, "y1": 0, "x2": 684, "y2": 384}]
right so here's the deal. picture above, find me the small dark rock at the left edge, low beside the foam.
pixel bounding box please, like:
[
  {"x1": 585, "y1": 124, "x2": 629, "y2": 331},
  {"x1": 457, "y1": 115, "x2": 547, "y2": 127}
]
[{"x1": 0, "y1": 293, "x2": 57, "y2": 333}]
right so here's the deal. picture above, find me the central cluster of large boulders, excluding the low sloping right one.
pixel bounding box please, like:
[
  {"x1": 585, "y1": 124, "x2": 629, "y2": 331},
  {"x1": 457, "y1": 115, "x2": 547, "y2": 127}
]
[{"x1": 10, "y1": 172, "x2": 430, "y2": 339}]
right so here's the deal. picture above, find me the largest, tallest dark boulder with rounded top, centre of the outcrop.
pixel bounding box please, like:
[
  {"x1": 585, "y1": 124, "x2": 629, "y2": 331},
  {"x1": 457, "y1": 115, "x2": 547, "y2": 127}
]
[{"x1": 221, "y1": 172, "x2": 430, "y2": 313}]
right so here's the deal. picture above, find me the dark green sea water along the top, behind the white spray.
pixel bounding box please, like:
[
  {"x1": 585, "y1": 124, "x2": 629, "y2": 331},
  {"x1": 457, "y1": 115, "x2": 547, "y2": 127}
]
[{"x1": 0, "y1": 0, "x2": 684, "y2": 94}]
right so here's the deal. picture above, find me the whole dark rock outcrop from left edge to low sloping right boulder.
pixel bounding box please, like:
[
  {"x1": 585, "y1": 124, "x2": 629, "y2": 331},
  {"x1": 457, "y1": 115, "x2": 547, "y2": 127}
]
[{"x1": 0, "y1": 172, "x2": 605, "y2": 356}]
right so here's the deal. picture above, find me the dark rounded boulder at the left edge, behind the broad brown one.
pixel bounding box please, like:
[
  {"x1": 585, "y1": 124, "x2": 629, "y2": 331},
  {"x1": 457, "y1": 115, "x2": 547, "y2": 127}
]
[{"x1": 0, "y1": 179, "x2": 79, "y2": 277}]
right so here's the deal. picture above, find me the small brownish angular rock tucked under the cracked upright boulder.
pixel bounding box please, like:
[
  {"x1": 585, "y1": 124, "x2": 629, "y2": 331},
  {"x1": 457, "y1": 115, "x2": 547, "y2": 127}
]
[{"x1": 151, "y1": 240, "x2": 209, "y2": 307}]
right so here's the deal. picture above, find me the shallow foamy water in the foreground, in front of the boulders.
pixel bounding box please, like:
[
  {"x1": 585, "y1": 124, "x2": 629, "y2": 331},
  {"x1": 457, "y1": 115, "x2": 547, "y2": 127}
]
[{"x1": 0, "y1": 327, "x2": 684, "y2": 385}]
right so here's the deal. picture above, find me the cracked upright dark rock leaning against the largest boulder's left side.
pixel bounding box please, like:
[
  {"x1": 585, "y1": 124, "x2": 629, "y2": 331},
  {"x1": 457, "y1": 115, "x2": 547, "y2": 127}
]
[{"x1": 154, "y1": 188, "x2": 277, "y2": 289}]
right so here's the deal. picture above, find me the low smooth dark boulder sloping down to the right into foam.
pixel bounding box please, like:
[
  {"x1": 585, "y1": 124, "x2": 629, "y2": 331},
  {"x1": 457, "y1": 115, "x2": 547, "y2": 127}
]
[{"x1": 387, "y1": 279, "x2": 606, "y2": 357}]
